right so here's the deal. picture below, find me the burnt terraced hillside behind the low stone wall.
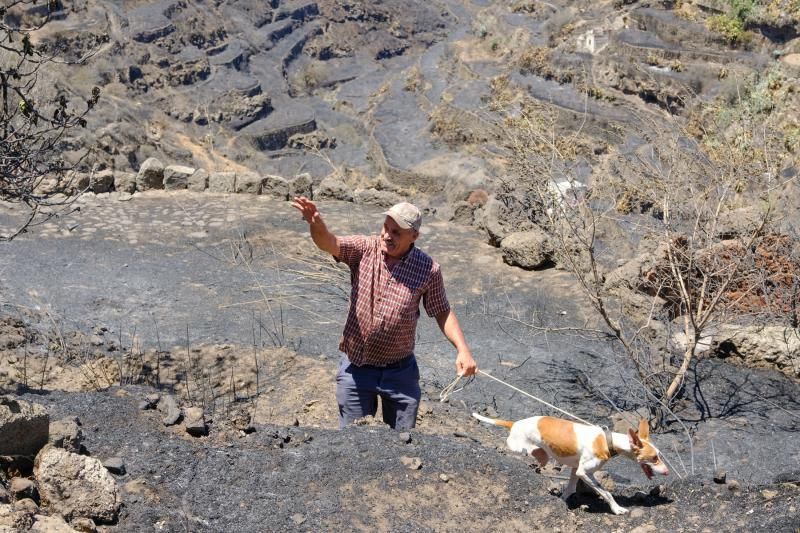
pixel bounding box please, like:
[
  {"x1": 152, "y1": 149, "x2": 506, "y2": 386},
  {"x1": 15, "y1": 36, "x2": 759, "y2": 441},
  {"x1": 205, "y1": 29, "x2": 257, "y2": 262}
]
[{"x1": 31, "y1": 0, "x2": 800, "y2": 207}]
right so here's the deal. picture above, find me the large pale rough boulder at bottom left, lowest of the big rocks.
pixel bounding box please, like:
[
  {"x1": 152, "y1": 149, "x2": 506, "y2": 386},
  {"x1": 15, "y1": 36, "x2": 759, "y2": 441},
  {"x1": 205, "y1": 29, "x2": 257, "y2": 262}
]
[{"x1": 34, "y1": 446, "x2": 120, "y2": 522}]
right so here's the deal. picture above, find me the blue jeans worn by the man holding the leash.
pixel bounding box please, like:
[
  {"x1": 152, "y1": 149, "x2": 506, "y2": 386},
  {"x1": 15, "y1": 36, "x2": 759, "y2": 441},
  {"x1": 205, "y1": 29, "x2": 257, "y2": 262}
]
[{"x1": 336, "y1": 355, "x2": 422, "y2": 430}]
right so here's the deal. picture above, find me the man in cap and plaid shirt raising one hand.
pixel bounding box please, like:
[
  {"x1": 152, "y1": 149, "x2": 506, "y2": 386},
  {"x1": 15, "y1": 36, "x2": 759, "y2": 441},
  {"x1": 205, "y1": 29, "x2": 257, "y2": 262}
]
[{"x1": 292, "y1": 196, "x2": 477, "y2": 429}]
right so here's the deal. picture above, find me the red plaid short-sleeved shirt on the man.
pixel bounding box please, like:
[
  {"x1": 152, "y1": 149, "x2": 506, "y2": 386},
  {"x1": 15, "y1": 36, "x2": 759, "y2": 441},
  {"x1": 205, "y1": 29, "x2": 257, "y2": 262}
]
[{"x1": 336, "y1": 235, "x2": 450, "y2": 366}]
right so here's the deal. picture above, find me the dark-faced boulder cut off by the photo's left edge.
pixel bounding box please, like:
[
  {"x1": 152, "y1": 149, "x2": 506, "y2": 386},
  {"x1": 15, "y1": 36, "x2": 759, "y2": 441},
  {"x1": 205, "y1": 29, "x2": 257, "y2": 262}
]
[{"x1": 0, "y1": 396, "x2": 50, "y2": 457}]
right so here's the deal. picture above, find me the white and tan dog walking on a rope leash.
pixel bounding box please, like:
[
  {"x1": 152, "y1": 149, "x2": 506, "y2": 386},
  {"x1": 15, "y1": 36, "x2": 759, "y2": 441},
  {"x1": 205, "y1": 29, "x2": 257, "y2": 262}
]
[{"x1": 472, "y1": 413, "x2": 669, "y2": 515}]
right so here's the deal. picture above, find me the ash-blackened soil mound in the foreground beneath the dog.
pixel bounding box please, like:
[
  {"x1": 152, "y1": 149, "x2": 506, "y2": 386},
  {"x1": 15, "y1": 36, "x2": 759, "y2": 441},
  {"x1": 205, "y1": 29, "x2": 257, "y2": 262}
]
[{"x1": 14, "y1": 387, "x2": 800, "y2": 531}]
